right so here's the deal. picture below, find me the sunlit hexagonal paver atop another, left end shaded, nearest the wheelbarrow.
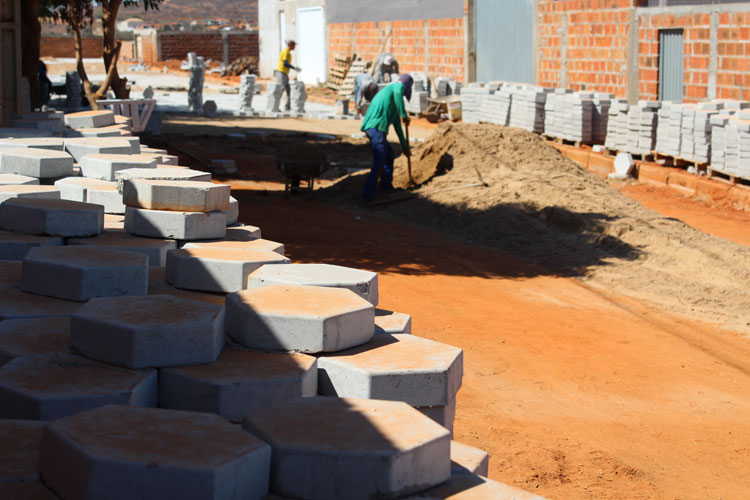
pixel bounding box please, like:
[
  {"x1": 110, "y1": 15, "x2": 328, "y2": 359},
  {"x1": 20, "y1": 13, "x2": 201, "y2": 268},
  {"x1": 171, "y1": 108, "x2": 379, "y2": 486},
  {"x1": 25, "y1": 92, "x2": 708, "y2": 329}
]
[{"x1": 122, "y1": 179, "x2": 231, "y2": 212}]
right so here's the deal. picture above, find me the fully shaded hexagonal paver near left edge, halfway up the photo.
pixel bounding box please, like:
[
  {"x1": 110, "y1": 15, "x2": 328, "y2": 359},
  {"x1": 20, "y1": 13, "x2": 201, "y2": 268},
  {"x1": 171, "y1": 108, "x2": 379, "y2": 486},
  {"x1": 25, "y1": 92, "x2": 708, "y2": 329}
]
[{"x1": 21, "y1": 246, "x2": 148, "y2": 302}]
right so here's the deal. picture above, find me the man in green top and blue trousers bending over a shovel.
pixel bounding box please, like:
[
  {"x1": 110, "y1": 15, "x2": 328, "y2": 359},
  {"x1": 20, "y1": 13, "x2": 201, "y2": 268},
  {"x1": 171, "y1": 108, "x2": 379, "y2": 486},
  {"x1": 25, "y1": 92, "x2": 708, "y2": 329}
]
[{"x1": 360, "y1": 75, "x2": 414, "y2": 202}]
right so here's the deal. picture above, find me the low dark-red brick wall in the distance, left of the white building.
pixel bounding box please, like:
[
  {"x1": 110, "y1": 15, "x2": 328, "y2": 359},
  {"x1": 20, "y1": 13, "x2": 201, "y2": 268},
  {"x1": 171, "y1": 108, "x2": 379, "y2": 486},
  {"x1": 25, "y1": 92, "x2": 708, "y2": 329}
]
[{"x1": 159, "y1": 32, "x2": 259, "y2": 62}]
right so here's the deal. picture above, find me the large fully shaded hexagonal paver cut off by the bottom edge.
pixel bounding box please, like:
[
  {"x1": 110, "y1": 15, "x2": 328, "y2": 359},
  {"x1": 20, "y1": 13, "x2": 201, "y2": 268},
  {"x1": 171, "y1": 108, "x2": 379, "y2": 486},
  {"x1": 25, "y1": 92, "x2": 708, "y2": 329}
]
[{"x1": 39, "y1": 406, "x2": 271, "y2": 500}]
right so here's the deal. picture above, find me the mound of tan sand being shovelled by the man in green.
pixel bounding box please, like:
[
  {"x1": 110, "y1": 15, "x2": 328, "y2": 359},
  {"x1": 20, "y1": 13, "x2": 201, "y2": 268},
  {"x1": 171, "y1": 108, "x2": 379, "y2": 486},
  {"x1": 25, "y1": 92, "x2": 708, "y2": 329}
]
[{"x1": 331, "y1": 124, "x2": 750, "y2": 332}]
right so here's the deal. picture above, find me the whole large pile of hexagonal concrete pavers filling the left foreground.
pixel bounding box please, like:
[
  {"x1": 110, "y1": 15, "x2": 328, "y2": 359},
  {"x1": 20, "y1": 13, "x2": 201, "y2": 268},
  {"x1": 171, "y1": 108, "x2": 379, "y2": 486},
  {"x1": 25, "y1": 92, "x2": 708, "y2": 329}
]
[{"x1": 0, "y1": 112, "x2": 539, "y2": 500}]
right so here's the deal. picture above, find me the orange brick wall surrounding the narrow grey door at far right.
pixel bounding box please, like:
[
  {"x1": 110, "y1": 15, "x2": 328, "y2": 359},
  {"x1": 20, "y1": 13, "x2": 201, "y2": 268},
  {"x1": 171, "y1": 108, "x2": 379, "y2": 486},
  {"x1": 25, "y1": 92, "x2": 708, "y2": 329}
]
[{"x1": 639, "y1": 9, "x2": 750, "y2": 102}]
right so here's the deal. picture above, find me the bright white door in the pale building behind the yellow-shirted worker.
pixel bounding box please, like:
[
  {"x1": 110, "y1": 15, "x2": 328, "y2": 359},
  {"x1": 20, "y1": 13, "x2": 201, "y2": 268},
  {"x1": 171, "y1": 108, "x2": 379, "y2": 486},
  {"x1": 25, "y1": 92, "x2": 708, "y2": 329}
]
[{"x1": 297, "y1": 7, "x2": 327, "y2": 84}]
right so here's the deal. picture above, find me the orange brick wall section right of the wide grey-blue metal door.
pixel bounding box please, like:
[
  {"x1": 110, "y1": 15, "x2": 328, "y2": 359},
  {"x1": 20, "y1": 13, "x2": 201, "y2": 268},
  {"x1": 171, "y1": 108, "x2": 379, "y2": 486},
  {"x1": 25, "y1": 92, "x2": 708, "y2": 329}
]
[{"x1": 538, "y1": 0, "x2": 634, "y2": 97}]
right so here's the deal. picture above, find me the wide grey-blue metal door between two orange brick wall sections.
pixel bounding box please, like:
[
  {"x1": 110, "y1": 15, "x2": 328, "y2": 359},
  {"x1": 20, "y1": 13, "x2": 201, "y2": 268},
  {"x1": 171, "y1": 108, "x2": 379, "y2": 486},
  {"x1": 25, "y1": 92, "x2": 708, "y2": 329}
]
[{"x1": 474, "y1": 0, "x2": 534, "y2": 83}]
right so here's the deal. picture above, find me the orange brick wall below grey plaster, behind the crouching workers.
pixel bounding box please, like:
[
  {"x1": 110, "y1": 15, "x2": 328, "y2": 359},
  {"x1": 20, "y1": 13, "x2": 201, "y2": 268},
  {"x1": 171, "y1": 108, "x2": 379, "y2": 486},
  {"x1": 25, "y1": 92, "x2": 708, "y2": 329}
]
[{"x1": 328, "y1": 18, "x2": 465, "y2": 81}]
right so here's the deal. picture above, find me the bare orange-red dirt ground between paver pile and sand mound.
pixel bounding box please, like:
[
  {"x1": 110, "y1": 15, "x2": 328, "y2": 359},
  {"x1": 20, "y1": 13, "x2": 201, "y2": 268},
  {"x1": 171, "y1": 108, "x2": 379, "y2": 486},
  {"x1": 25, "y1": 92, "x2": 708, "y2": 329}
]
[{"x1": 234, "y1": 185, "x2": 750, "y2": 500}]
